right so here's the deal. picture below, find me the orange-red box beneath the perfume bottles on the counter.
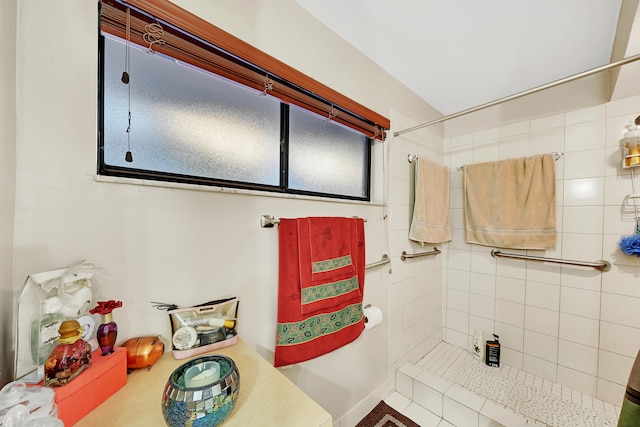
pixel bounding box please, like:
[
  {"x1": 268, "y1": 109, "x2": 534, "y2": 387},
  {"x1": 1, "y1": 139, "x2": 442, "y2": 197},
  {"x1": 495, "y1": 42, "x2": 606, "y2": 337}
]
[{"x1": 54, "y1": 347, "x2": 127, "y2": 427}]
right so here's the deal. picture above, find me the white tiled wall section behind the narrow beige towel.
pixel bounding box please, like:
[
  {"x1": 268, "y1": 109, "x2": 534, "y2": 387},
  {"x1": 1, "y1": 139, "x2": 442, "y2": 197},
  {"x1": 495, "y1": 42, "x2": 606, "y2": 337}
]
[{"x1": 385, "y1": 111, "x2": 444, "y2": 391}]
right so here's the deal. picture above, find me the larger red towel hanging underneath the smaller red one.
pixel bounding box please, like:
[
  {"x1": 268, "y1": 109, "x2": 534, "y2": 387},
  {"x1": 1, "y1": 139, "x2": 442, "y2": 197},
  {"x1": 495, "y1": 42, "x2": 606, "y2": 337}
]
[{"x1": 274, "y1": 218, "x2": 365, "y2": 367}]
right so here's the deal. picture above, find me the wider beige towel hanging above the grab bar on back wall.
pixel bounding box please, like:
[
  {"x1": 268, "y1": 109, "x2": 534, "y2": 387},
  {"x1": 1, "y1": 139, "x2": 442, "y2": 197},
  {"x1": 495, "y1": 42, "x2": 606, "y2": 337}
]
[{"x1": 464, "y1": 154, "x2": 556, "y2": 249}]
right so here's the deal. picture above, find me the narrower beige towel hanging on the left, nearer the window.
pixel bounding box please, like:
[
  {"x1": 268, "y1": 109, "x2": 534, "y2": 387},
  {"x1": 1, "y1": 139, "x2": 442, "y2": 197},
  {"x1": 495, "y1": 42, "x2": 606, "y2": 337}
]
[{"x1": 409, "y1": 158, "x2": 451, "y2": 244}]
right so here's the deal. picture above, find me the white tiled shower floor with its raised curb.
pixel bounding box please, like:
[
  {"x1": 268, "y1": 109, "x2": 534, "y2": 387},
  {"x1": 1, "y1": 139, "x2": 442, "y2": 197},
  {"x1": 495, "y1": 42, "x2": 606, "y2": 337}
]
[{"x1": 385, "y1": 342, "x2": 620, "y2": 427}]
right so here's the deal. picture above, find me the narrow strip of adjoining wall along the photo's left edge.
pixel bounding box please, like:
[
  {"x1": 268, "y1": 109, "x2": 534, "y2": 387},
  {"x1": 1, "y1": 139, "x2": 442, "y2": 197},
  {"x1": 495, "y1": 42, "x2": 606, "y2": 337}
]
[{"x1": 0, "y1": 0, "x2": 17, "y2": 390}]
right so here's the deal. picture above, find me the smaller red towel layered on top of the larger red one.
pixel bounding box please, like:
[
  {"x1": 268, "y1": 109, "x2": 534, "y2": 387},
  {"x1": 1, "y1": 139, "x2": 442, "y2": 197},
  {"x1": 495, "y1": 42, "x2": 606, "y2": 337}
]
[{"x1": 296, "y1": 217, "x2": 364, "y2": 313}]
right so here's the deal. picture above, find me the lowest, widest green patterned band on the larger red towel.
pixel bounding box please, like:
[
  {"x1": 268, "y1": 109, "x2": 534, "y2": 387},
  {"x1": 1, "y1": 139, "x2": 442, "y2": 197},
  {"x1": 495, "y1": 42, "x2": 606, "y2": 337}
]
[{"x1": 276, "y1": 303, "x2": 364, "y2": 345}]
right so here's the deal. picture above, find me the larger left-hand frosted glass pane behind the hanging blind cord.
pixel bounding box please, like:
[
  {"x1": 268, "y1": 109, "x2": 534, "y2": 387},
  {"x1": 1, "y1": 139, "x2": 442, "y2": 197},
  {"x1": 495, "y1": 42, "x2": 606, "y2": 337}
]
[{"x1": 103, "y1": 37, "x2": 280, "y2": 186}]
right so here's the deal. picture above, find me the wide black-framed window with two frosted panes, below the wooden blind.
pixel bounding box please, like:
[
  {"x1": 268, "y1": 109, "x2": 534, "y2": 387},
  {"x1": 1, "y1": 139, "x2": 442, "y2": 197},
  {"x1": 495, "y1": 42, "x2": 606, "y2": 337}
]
[{"x1": 98, "y1": 35, "x2": 371, "y2": 200}]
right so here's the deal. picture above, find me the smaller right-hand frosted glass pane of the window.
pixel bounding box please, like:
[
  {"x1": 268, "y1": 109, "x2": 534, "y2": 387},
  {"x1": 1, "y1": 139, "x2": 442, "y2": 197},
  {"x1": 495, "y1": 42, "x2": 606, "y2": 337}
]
[{"x1": 289, "y1": 106, "x2": 370, "y2": 199}]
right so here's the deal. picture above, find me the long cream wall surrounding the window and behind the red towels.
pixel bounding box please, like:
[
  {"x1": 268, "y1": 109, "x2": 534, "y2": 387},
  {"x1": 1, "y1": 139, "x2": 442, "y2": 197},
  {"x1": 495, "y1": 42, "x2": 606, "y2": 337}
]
[{"x1": 7, "y1": 0, "x2": 442, "y2": 426}]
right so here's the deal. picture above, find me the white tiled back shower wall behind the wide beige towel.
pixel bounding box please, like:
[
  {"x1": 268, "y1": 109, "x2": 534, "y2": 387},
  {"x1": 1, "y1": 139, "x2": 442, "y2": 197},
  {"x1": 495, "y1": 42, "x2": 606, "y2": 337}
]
[{"x1": 443, "y1": 97, "x2": 640, "y2": 405}]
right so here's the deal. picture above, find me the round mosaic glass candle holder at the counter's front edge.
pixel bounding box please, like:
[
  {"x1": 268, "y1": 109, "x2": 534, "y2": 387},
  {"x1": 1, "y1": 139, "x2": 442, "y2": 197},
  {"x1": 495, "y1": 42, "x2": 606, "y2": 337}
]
[{"x1": 162, "y1": 354, "x2": 240, "y2": 427}]
